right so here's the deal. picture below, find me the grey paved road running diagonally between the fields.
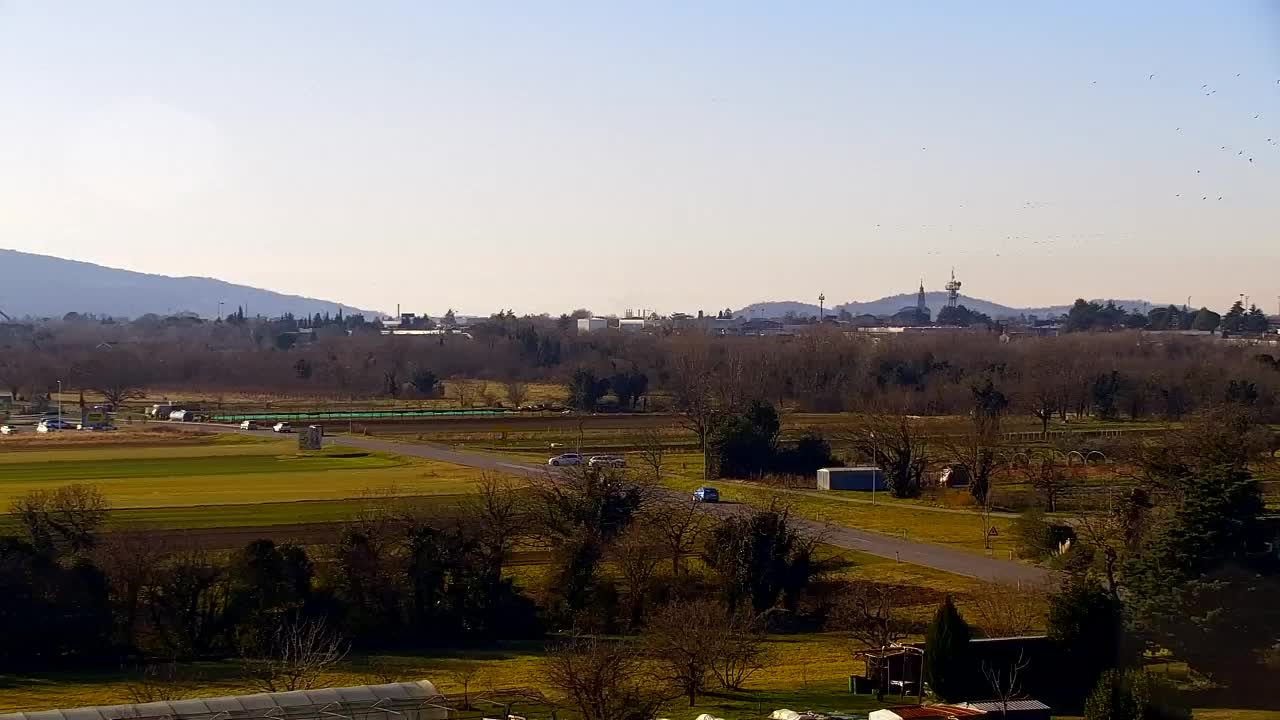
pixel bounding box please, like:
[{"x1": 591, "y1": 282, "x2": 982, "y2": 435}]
[{"x1": 175, "y1": 424, "x2": 1052, "y2": 583}]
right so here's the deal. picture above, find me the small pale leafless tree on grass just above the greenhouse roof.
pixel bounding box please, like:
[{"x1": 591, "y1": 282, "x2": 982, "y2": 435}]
[{"x1": 243, "y1": 620, "x2": 347, "y2": 693}]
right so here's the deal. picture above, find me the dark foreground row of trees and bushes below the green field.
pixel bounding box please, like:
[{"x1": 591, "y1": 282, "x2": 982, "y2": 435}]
[{"x1": 0, "y1": 464, "x2": 827, "y2": 697}]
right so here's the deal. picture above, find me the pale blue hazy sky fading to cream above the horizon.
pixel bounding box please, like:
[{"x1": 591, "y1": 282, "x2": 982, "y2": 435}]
[{"x1": 0, "y1": 0, "x2": 1280, "y2": 314}]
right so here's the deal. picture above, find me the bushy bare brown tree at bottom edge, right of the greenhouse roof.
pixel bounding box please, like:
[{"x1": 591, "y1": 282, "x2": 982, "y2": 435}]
[{"x1": 544, "y1": 637, "x2": 678, "y2": 720}]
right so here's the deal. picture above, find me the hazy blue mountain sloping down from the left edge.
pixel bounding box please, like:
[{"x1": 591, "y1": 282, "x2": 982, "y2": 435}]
[{"x1": 0, "y1": 249, "x2": 381, "y2": 319}]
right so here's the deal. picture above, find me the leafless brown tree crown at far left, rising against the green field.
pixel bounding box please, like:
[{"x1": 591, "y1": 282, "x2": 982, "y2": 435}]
[{"x1": 9, "y1": 484, "x2": 110, "y2": 552}]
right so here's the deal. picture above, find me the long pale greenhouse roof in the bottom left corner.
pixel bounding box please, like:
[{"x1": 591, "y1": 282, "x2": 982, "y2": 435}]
[{"x1": 0, "y1": 680, "x2": 449, "y2": 720}]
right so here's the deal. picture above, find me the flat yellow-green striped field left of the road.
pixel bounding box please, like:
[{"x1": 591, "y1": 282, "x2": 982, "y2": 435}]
[{"x1": 0, "y1": 430, "x2": 491, "y2": 528}]
